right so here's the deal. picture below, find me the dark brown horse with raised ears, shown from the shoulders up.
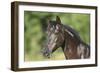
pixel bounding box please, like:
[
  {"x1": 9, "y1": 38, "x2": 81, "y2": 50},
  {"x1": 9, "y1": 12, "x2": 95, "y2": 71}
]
[{"x1": 43, "y1": 16, "x2": 90, "y2": 60}]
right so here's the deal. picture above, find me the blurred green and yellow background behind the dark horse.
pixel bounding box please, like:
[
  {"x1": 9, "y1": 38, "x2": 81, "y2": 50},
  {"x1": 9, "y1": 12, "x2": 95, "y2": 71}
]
[{"x1": 24, "y1": 11, "x2": 90, "y2": 61}]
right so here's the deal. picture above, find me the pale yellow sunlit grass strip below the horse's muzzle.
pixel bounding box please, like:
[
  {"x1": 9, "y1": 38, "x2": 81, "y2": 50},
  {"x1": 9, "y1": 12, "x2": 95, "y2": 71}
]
[{"x1": 25, "y1": 48, "x2": 65, "y2": 61}]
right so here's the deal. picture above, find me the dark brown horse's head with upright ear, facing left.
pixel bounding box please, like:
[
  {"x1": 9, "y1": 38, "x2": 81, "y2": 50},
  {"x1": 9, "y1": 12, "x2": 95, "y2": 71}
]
[{"x1": 43, "y1": 16, "x2": 64, "y2": 58}]
